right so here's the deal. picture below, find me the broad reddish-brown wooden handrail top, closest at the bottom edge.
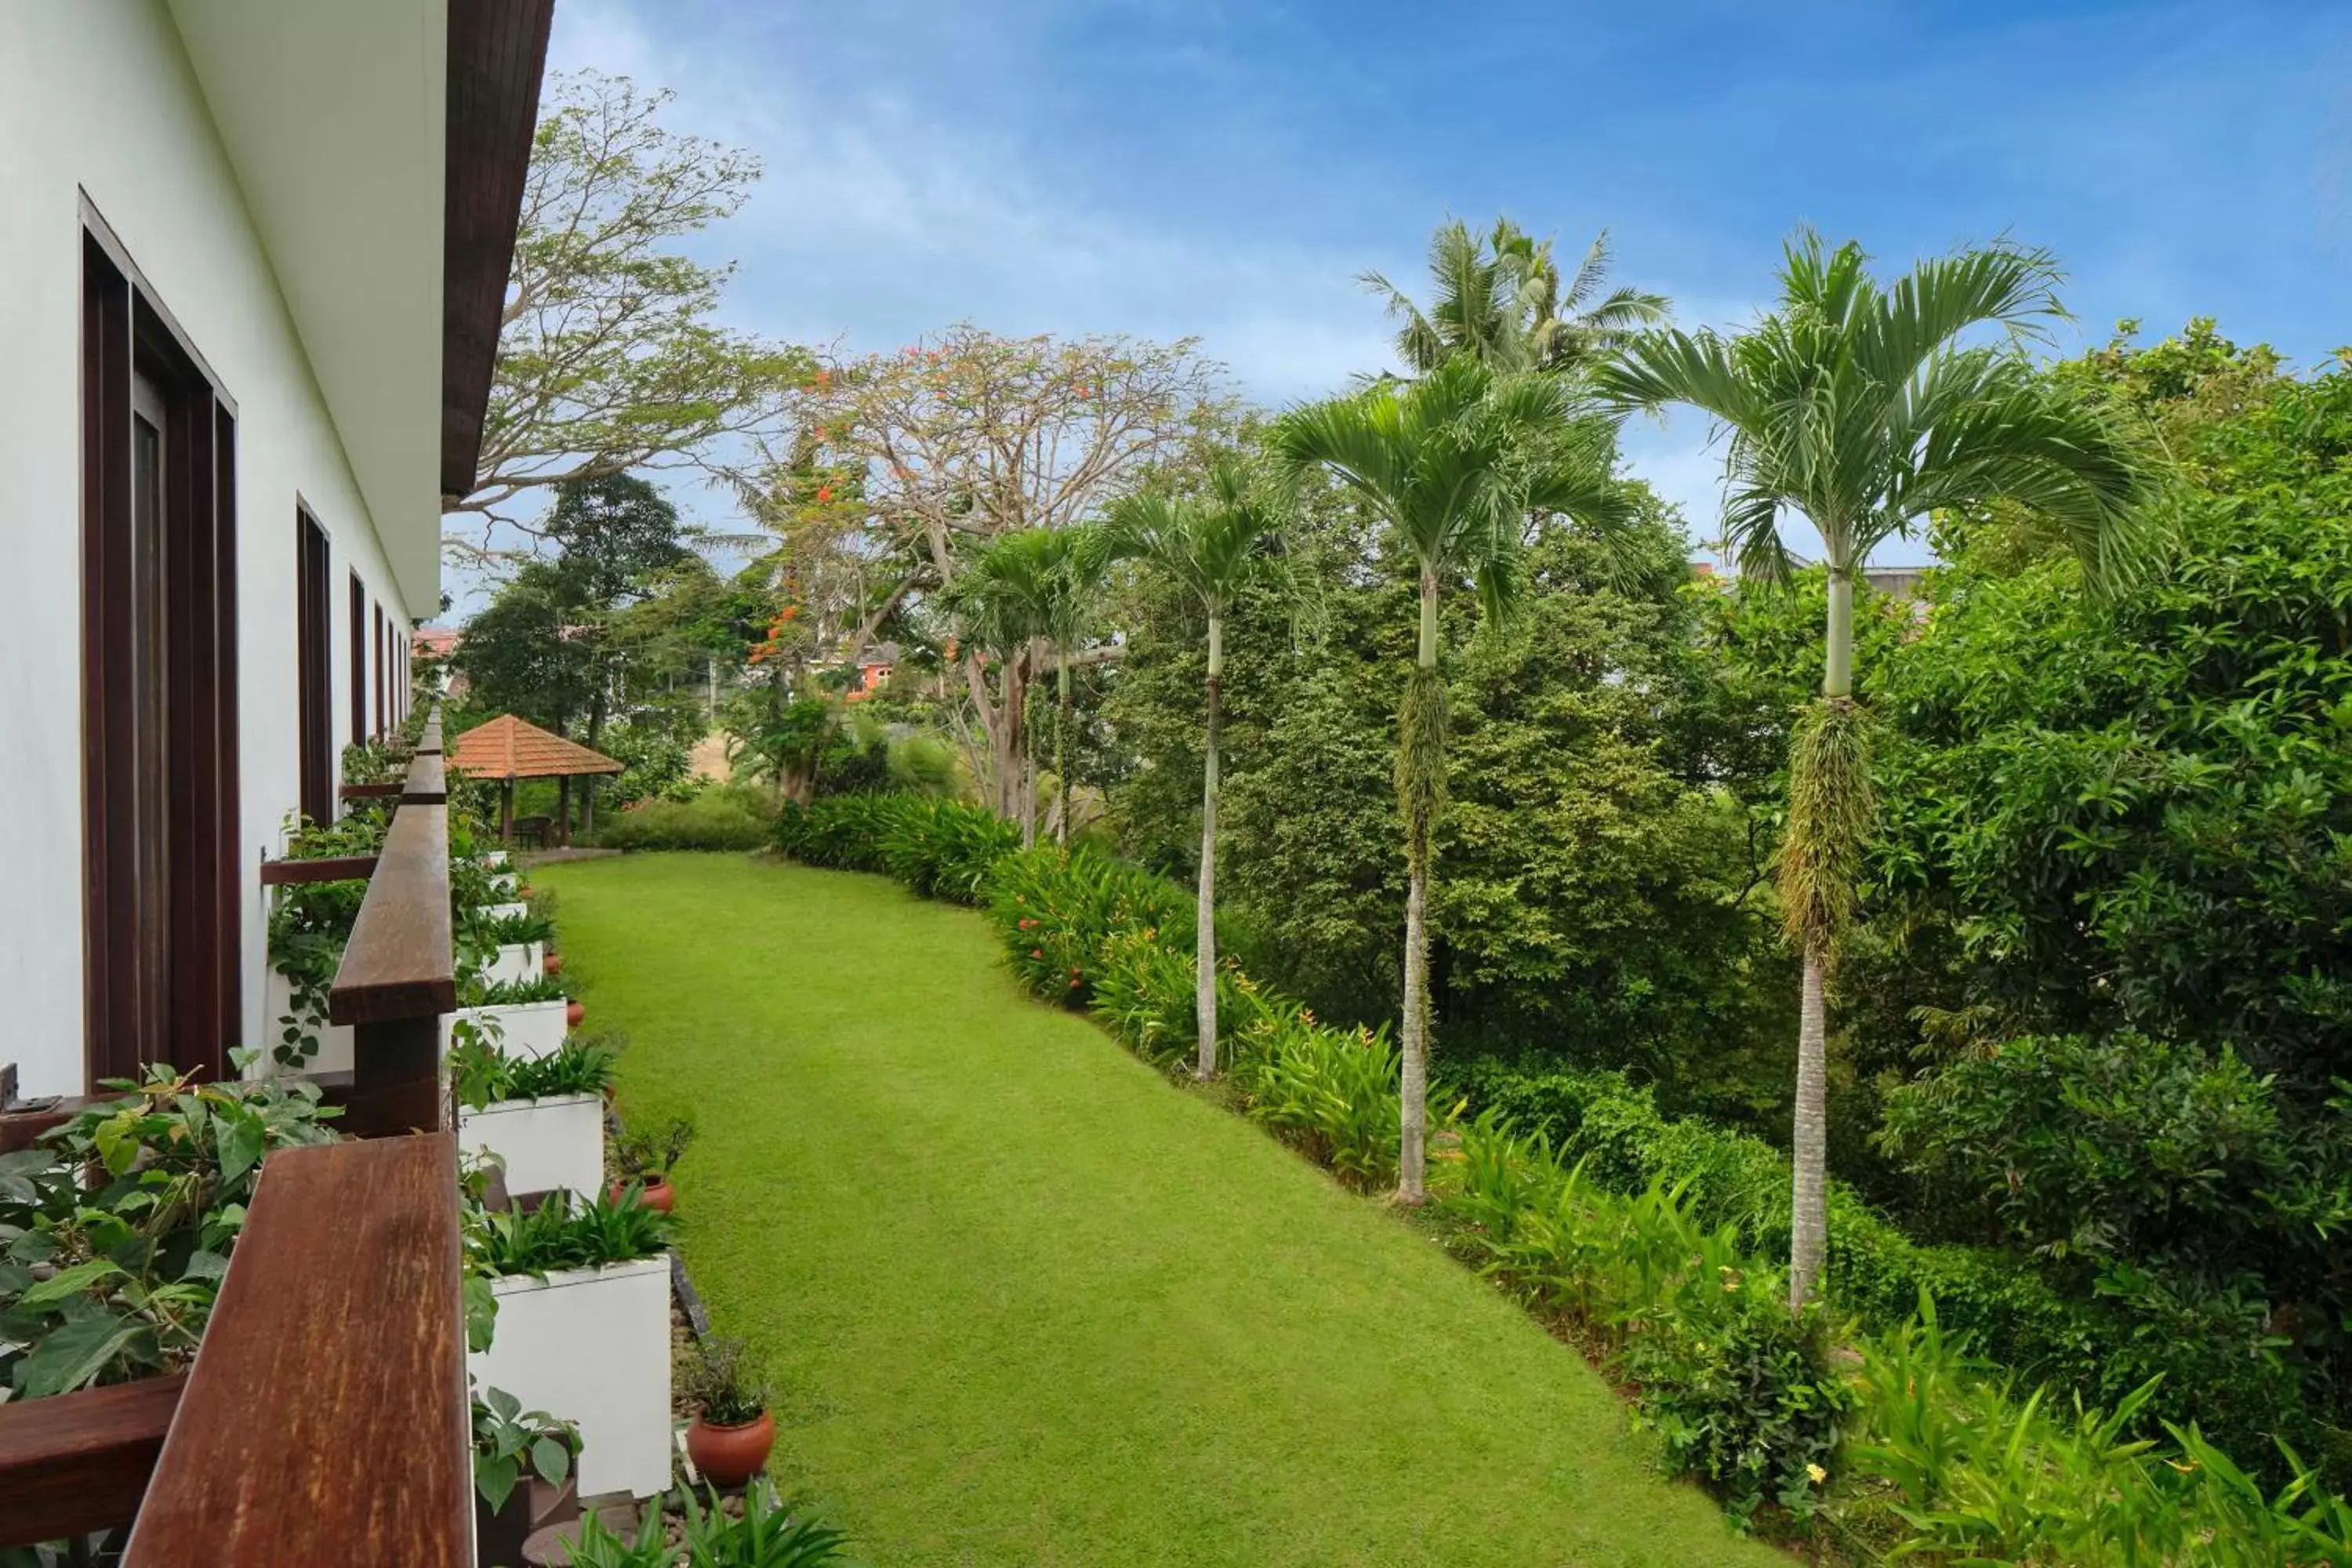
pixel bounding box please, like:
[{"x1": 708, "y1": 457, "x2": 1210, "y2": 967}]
[{"x1": 122, "y1": 1133, "x2": 473, "y2": 1568}]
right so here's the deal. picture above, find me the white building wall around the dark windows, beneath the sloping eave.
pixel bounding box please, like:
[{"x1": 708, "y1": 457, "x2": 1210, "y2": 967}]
[{"x1": 0, "y1": 0, "x2": 419, "y2": 1093}]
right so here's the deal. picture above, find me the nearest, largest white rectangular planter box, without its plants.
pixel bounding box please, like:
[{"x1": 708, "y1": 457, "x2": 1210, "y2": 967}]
[{"x1": 466, "y1": 1253, "x2": 670, "y2": 1497}]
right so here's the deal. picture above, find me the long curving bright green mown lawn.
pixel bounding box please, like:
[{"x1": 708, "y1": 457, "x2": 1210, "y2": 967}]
[{"x1": 532, "y1": 855, "x2": 1788, "y2": 1568}]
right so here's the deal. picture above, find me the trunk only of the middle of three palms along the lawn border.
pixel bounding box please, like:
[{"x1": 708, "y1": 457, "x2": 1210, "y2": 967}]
[{"x1": 1397, "y1": 569, "x2": 1446, "y2": 1203}]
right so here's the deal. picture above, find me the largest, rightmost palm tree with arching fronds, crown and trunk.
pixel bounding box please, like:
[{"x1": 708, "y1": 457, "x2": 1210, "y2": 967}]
[{"x1": 1602, "y1": 230, "x2": 2152, "y2": 1309}]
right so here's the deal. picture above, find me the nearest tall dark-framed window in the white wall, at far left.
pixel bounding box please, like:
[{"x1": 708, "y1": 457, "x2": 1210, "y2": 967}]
[{"x1": 82, "y1": 230, "x2": 242, "y2": 1083}]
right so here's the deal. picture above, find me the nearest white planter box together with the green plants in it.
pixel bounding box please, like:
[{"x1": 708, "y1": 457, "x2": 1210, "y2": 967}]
[{"x1": 466, "y1": 1199, "x2": 670, "y2": 1497}]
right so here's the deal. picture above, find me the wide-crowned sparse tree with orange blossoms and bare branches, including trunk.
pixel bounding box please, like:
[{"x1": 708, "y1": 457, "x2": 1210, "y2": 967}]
[{"x1": 786, "y1": 327, "x2": 1230, "y2": 815}]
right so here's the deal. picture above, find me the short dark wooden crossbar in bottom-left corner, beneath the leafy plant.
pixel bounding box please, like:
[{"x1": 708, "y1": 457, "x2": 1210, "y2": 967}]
[{"x1": 0, "y1": 1373, "x2": 186, "y2": 1549}]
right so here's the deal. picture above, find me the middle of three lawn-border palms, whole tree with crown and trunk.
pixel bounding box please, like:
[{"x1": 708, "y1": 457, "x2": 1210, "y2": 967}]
[{"x1": 1268, "y1": 355, "x2": 1628, "y2": 1203}]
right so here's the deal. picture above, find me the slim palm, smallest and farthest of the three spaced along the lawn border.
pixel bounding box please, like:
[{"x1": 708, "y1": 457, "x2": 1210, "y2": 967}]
[{"x1": 1110, "y1": 454, "x2": 1289, "y2": 1079}]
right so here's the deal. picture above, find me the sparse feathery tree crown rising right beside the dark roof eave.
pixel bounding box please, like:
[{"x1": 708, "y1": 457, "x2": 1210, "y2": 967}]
[{"x1": 442, "y1": 71, "x2": 809, "y2": 562}]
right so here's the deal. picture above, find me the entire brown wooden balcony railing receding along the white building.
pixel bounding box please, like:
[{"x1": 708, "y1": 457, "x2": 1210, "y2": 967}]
[{"x1": 0, "y1": 713, "x2": 473, "y2": 1568}]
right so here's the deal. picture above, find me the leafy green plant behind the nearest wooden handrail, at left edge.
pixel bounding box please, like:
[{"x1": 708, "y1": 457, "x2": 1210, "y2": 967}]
[{"x1": 0, "y1": 1067, "x2": 336, "y2": 1399}]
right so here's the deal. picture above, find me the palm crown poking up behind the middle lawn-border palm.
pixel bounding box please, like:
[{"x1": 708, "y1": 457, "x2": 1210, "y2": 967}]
[{"x1": 1362, "y1": 219, "x2": 1665, "y2": 376}]
